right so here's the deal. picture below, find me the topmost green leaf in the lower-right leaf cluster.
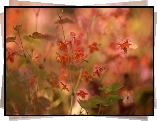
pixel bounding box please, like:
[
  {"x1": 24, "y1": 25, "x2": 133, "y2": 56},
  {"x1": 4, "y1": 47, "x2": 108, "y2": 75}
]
[{"x1": 99, "y1": 82, "x2": 123, "y2": 92}]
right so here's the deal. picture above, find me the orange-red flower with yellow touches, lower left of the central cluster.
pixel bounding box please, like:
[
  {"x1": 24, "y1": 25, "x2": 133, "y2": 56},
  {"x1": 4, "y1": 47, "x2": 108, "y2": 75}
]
[{"x1": 56, "y1": 52, "x2": 71, "y2": 66}]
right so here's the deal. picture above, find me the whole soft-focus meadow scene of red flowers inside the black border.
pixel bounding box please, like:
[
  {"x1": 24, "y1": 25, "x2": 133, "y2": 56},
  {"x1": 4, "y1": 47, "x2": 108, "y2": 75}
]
[{"x1": 5, "y1": 8, "x2": 154, "y2": 115}]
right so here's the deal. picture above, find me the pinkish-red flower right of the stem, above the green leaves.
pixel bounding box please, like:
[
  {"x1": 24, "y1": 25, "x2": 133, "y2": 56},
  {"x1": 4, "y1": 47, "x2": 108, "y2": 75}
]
[{"x1": 93, "y1": 65, "x2": 106, "y2": 78}]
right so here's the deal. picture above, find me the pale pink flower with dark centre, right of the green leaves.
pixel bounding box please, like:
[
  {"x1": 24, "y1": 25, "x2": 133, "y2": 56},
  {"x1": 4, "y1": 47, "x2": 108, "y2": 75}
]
[{"x1": 122, "y1": 91, "x2": 134, "y2": 105}]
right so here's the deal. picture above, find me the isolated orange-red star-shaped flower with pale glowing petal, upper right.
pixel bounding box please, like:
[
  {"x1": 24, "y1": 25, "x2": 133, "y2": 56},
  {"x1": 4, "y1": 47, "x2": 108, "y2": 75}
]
[{"x1": 117, "y1": 39, "x2": 138, "y2": 53}]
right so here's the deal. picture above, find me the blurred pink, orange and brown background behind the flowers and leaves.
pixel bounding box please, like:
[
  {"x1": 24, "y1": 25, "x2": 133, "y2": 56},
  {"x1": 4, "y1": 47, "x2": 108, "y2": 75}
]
[{"x1": 6, "y1": 8, "x2": 154, "y2": 115}]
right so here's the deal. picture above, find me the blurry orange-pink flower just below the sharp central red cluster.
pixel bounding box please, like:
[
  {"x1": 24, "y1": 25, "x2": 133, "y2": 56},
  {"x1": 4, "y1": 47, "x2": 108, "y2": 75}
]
[{"x1": 58, "y1": 68, "x2": 70, "y2": 82}]
